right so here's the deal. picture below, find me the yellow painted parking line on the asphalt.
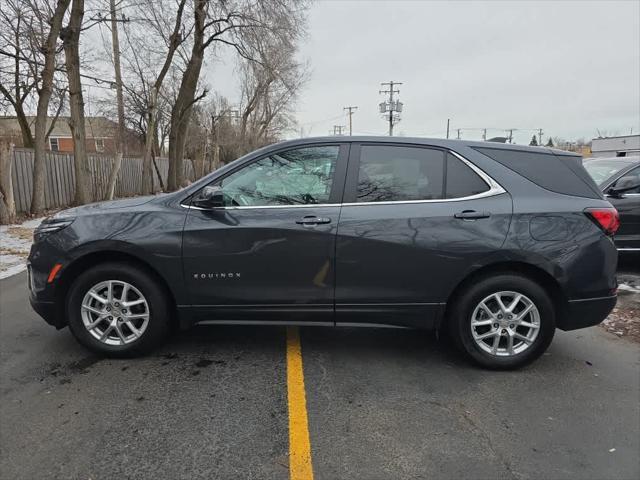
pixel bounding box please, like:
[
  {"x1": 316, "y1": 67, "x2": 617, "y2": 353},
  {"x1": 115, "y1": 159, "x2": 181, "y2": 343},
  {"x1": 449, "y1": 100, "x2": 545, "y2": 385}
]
[{"x1": 287, "y1": 327, "x2": 313, "y2": 480}]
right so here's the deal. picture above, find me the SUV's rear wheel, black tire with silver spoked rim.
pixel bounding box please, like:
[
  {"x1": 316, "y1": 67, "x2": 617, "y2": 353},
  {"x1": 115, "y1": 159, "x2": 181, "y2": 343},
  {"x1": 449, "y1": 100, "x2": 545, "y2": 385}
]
[{"x1": 448, "y1": 274, "x2": 556, "y2": 370}]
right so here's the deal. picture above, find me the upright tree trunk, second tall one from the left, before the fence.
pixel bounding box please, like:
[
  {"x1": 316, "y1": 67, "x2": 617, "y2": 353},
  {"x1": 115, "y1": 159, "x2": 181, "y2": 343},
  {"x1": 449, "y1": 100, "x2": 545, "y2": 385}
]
[{"x1": 60, "y1": 0, "x2": 93, "y2": 205}]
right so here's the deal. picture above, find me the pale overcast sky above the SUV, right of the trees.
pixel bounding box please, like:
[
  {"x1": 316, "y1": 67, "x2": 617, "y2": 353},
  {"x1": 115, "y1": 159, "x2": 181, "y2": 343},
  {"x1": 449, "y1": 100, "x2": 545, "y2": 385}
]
[{"x1": 286, "y1": 0, "x2": 640, "y2": 143}]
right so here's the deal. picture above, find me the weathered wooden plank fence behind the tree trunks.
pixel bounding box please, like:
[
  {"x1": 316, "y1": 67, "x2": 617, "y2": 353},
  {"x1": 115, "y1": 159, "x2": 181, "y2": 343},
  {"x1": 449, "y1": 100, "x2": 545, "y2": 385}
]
[{"x1": 11, "y1": 148, "x2": 195, "y2": 213}]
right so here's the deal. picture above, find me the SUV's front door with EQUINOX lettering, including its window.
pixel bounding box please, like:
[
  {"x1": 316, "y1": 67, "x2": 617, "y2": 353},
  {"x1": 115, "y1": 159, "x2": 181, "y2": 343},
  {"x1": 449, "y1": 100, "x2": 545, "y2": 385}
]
[{"x1": 183, "y1": 143, "x2": 348, "y2": 322}]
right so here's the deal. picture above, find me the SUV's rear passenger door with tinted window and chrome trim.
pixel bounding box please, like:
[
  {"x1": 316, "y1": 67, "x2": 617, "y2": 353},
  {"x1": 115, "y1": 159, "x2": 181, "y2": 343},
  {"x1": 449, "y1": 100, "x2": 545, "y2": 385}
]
[{"x1": 336, "y1": 144, "x2": 512, "y2": 326}]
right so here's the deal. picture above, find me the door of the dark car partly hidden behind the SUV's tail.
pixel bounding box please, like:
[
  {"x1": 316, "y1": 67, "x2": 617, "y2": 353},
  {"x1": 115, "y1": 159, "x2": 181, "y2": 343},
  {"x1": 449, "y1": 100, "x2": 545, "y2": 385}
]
[{"x1": 607, "y1": 167, "x2": 640, "y2": 251}]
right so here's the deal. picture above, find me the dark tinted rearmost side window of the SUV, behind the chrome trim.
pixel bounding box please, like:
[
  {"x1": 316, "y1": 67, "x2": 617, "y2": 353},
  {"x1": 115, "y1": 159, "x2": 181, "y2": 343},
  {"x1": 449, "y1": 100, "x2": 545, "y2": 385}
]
[{"x1": 475, "y1": 147, "x2": 601, "y2": 198}]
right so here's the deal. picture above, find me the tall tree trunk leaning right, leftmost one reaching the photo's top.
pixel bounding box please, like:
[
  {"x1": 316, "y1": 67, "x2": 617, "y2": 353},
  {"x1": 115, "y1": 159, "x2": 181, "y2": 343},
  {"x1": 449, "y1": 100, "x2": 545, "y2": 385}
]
[{"x1": 30, "y1": 0, "x2": 71, "y2": 215}]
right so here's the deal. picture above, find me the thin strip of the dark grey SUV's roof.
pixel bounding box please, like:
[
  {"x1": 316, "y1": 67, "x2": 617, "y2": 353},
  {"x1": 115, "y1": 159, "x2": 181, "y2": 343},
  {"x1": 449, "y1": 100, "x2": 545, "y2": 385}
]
[{"x1": 278, "y1": 135, "x2": 580, "y2": 157}]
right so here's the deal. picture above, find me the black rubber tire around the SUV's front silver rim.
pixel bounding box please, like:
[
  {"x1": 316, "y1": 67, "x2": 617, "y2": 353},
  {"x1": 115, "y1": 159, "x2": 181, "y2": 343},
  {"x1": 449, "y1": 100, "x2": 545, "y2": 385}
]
[{"x1": 66, "y1": 262, "x2": 171, "y2": 358}]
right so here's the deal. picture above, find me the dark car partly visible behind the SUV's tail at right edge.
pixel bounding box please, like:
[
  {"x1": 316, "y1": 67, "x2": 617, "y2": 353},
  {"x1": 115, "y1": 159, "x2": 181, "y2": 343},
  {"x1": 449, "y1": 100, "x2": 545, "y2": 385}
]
[{"x1": 584, "y1": 157, "x2": 640, "y2": 254}]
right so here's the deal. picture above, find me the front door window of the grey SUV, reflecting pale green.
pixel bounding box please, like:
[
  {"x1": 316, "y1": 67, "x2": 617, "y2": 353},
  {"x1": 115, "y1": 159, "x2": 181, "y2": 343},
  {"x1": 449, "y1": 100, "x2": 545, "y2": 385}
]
[{"x1": 217, "y1": 145, "x2": 340, "y2": 206}]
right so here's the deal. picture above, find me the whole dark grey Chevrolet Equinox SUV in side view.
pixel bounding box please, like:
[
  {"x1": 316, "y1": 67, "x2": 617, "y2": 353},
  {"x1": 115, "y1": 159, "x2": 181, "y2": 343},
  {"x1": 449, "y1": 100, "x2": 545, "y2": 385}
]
[{"x1": 29, "y1": 137, "x2": 617, "y2": 368}]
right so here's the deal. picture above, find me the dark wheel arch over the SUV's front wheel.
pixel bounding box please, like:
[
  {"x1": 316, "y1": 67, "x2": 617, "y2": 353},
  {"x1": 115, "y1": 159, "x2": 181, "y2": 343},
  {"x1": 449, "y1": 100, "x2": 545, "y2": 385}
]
[{"x1": 54, "y1": 250, "x2": 178, "y2": 324}]
